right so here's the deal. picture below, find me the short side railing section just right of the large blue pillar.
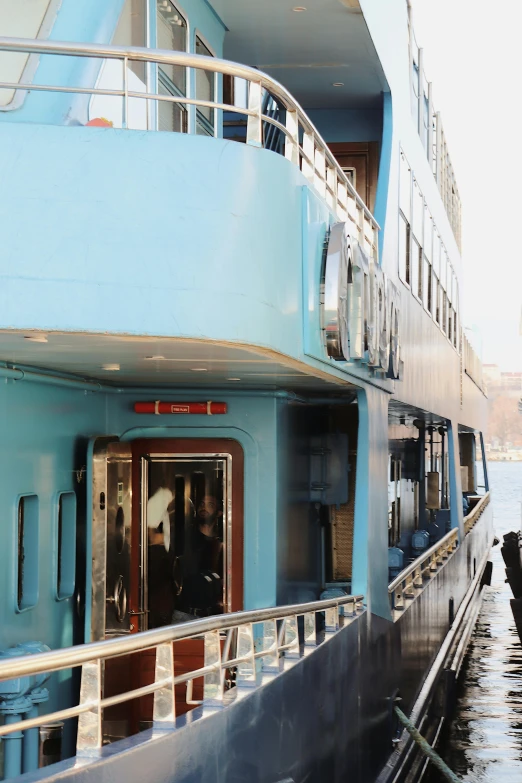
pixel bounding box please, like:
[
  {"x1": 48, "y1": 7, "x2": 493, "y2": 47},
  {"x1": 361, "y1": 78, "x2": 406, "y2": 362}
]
[{"x1": 388, "y1": 528, "x2": 459, "y2": 610}]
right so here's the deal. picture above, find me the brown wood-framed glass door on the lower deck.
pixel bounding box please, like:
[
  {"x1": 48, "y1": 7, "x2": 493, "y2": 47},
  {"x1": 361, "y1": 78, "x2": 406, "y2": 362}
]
[{"x1": 130, "y1": 439, "x2": 244, "y2": 731}]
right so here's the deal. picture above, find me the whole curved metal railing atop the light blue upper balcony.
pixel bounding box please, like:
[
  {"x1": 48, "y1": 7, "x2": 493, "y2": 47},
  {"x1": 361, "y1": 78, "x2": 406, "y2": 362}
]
[{"x1": 0, "y1": 37, "x2": 379, "y2": 259}]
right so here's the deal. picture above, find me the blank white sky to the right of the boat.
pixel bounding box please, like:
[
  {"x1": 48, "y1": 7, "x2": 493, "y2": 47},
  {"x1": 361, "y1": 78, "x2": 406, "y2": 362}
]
[{"x1": 412, "y1": 0, "x2": 522, "y2": 371}]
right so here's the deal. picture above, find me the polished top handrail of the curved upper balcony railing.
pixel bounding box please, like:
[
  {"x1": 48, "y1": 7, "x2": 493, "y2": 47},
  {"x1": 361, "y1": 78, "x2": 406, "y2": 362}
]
[{"x1": 0, "y1": 36, "x2": 379, "y2": 229}]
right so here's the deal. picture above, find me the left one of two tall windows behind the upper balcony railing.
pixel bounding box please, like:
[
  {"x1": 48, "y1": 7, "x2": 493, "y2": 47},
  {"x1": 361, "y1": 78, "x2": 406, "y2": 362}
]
[{"x1": 156, "y1": 0, "x2": 187, "y2": 133}]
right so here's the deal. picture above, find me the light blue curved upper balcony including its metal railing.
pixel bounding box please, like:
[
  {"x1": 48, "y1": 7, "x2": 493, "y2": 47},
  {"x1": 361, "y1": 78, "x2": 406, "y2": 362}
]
[{"x1": 0, "y1": 38, "x2": 378, "y2": 382}]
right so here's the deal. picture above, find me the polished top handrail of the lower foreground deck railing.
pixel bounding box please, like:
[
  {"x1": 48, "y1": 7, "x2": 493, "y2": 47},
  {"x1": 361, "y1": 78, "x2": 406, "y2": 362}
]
[{"x1": 0, "y1": 595, "x2": 364, "y2": 681}]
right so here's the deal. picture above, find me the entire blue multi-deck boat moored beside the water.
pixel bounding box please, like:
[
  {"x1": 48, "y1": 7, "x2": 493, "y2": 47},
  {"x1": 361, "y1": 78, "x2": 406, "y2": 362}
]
[{"x1": 0, "y1": 0, "x2": 493, "y2": 783}]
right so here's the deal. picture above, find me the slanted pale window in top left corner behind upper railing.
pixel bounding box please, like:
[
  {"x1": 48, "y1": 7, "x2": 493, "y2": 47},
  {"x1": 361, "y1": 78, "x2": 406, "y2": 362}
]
[{"x1": 0, "y1": 0, "x2": 58, "y2": 109}]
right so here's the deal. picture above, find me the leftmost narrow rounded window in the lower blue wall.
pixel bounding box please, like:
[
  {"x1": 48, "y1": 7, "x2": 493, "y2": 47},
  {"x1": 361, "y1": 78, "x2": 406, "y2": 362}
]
[{"x1": 16, "y1": 495, "x2": 38, "y2": 612}]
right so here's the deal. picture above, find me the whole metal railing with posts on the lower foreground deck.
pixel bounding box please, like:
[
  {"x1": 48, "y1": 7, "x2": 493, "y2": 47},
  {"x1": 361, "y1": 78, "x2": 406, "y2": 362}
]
[{"x1": 0, "y1": 595, "x2": 363, "y2": 755}]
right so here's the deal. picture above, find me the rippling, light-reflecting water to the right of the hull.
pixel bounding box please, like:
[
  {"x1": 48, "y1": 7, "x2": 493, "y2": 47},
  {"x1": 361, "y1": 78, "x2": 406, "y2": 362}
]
[{"x1": 428, "y1": 462, "x2": 522, "y2": 783}]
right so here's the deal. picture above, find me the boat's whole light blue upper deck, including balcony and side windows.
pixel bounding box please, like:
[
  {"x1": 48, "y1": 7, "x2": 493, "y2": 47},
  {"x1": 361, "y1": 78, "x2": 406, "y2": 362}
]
[{"x1": 0, "y1": 0, "x2": 484, "y2": 428}]
